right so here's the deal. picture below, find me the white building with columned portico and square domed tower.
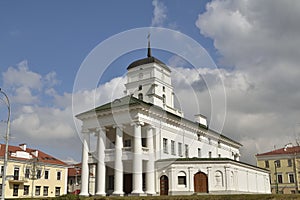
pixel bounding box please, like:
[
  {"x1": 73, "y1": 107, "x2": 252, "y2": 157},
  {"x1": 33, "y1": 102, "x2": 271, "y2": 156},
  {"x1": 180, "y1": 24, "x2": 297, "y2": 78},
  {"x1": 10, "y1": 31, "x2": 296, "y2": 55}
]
[{"x1": 76, "y1": 47, "x2": 270, "y2": 196}]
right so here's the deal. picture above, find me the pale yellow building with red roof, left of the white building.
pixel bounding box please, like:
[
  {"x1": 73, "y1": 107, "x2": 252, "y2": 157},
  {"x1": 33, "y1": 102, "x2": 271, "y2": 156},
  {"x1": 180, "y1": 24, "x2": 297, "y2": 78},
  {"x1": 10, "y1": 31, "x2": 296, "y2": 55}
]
[{"x1": 0, "y1": 144, "x2": 68, "y2": 198}]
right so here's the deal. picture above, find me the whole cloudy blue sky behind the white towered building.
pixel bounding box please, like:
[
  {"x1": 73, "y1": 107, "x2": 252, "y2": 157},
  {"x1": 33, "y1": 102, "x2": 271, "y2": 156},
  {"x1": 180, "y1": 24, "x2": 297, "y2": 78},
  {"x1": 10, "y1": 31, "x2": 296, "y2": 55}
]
[{"x1": 0, "y1": 0, "x2": 300, "y2": 164}]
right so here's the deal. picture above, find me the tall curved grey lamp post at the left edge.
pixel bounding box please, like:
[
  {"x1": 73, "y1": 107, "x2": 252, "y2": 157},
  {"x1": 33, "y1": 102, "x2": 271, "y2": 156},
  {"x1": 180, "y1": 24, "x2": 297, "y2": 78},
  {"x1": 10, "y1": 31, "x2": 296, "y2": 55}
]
[{"x1": 0, "y1": 88, "x2": 10, "y2": 200}]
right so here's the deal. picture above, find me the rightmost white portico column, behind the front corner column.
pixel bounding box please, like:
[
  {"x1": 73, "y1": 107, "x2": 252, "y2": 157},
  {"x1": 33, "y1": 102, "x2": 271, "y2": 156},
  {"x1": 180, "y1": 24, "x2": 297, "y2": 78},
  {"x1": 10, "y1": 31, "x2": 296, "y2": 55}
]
[{"x1": 146, "y1": 126, "x2": 156, "y2": 195}]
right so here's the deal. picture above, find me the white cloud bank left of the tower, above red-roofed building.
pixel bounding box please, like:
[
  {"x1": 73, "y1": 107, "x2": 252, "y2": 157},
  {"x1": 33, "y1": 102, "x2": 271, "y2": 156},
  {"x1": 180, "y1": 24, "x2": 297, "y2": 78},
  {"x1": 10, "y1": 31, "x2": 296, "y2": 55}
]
[{"x1": 2, "y1": 61, "x2": 126, "y2": 162}]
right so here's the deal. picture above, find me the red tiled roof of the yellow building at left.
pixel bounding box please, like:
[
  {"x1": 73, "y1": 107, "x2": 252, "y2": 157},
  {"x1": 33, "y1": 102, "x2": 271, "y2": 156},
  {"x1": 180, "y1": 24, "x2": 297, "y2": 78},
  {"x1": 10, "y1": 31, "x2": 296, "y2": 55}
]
[{"x1": 0, "y1": 144, "x2": 67, "y2": 165}]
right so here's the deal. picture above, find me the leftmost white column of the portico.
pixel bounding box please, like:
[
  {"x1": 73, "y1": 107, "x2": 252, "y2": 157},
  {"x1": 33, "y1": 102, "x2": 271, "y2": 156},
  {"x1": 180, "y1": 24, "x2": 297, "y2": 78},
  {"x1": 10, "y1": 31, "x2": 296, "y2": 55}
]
[{"x1": 79, "y1": 130, "x2": 90, "y2": 196}]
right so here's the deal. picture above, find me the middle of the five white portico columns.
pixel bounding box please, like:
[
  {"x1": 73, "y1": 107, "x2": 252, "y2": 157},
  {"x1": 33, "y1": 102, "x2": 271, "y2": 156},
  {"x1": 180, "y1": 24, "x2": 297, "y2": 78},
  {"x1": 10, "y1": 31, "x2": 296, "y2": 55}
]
[{"x1": 113, "y1": 127, "x2": 124, "y2": 196}]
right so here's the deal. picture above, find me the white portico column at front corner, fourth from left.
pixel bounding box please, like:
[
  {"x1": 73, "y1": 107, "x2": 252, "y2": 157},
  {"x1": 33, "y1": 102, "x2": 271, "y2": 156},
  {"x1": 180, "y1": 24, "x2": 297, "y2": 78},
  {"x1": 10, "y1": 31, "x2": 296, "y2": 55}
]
[{"x1": 131, "y1": 122, "x2": 144, "y2": 195}]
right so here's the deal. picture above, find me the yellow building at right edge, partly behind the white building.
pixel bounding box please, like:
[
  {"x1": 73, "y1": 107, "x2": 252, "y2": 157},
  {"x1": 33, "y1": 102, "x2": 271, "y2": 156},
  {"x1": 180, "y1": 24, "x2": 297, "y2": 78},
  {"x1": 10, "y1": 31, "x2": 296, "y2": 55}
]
[{"x1": 256, "y1": 145, "x2": 300, "y2": 194}]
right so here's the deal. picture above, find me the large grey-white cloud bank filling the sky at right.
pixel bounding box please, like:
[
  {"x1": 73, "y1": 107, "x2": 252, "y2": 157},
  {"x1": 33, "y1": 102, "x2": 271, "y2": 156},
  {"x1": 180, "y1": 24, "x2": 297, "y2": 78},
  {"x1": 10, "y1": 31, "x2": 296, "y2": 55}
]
[{"x1": 196, "y1": 0, "x2": 300, "y2": 164}]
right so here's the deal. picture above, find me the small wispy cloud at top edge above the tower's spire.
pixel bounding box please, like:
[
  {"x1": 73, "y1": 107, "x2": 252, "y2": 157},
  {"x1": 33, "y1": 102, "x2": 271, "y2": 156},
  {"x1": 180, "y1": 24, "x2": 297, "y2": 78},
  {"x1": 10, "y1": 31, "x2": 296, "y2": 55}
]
[{"x1": 151, "y1": 0, "x2": 167, "y2": 26}]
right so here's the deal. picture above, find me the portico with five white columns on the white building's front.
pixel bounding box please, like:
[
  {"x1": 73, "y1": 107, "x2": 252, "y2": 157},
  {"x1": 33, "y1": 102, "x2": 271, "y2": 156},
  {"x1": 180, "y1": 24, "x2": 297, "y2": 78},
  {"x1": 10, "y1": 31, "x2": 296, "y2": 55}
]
[{"x1": 80, "y1": 118, "x2": 155, "y2": 196}]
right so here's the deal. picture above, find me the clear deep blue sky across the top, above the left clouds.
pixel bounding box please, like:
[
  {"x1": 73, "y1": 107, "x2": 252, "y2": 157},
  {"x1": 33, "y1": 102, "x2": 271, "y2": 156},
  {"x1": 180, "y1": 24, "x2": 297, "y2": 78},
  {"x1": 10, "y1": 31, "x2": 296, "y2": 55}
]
[{"x1": 0, "y1": 1, "x2": 214, "y2": 92}]
